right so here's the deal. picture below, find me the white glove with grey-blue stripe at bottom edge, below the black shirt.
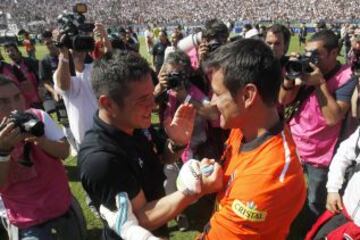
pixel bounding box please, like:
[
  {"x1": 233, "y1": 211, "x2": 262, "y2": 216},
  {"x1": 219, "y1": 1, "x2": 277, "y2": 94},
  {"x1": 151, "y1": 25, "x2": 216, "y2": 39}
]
[{"x1": 100, "y1": 192, "x2": 160, "y2": 240}]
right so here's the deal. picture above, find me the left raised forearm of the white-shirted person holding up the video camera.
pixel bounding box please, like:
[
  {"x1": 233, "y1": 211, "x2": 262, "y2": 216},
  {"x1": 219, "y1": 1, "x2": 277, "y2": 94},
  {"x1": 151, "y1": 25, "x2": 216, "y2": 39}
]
[{"x1": 54, "y1": 53, "x2": 71, "y2": 91}]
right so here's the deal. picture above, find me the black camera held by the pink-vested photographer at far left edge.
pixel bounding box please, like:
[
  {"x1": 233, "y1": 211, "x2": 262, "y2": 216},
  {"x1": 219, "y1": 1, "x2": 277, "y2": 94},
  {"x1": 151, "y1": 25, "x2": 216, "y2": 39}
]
[{"x1": 9, "y1": 111, "x2": 45, "y2": 137}]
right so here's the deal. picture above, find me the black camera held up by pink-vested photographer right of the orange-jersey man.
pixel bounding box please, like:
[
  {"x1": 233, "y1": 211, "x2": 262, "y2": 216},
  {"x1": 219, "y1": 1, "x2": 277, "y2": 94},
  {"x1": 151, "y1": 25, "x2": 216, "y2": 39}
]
[{"x1": 285, "y1": 50, "x2": 319, "y2": 80}]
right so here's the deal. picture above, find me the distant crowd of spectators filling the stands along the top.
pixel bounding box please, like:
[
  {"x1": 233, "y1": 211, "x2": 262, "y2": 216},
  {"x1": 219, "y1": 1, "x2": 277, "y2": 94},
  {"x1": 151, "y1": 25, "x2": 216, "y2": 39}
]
[{"x1": 0, "y1": 0, "x2": 357, "y2": 26}]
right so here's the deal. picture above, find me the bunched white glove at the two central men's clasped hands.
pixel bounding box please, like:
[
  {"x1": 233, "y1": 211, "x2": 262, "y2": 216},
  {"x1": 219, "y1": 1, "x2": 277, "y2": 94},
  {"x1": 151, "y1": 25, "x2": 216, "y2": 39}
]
[{"x1": 176, "y1": 159, "x2": 214, "y2": 195}]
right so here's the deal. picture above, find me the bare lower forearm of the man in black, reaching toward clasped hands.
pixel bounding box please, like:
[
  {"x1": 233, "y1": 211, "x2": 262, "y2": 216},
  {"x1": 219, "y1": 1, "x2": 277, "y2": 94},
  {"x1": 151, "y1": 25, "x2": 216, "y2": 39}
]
[{"x1": 135, "y1": 191, "x2": 198, "y2": 231}]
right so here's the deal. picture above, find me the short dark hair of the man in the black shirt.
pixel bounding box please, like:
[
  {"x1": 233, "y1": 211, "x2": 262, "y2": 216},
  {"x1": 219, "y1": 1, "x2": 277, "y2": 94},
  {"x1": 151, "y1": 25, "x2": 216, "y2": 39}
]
[{"x1": 91, "y1": 50, "x2": 151, "y2": 106}]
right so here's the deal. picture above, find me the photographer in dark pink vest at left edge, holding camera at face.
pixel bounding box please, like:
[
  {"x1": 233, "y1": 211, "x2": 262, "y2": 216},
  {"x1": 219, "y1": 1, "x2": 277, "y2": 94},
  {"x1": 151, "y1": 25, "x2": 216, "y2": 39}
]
[{"x1": 0, "y1": 76, "x2": 81, "y2": 240}]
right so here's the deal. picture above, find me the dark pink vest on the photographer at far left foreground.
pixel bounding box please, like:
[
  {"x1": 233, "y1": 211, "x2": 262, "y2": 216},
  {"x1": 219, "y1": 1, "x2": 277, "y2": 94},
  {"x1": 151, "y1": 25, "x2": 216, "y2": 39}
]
[{"x1": 0, "y1": 109, "x2": 71, "y2": 229}]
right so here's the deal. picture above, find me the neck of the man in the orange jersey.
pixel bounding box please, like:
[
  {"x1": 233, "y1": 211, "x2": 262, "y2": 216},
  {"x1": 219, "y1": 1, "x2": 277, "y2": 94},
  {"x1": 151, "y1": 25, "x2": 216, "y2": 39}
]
[{"x1": 240, "y1": 107, "x2": 280, "y2": 142}]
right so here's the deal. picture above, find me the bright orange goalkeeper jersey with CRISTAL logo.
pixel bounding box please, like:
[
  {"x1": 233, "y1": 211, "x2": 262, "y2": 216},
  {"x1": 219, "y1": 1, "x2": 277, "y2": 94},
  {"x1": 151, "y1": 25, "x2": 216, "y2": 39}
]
[{"x1": 202, "y1": 123, "x2": 306, "y2": 240}]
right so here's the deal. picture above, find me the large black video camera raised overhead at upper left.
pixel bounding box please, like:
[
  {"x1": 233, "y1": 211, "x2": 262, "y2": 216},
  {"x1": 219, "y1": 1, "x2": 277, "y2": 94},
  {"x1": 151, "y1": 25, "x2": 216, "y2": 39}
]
[{"x1": 56, "y1": 3, "x2": 95, "y2": 52}]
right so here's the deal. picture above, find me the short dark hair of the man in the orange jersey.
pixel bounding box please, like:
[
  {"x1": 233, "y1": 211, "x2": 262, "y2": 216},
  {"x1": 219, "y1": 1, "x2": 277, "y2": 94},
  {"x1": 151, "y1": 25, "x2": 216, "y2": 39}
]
[{"x1": 205, "y1": 39, "x2": 281, "y2": 106}]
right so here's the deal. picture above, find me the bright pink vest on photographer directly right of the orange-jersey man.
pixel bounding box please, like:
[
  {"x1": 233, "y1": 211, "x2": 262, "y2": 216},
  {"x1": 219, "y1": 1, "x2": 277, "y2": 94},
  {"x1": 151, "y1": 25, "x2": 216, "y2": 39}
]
[{"x1": 289, "y1": 65, "x2": 352, "y2": 167}]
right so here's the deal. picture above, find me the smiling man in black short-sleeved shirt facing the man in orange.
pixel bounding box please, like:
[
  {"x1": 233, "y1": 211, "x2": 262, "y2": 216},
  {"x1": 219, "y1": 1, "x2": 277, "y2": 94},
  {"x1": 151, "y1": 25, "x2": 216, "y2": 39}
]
[{"x1": 78, "y1": 51, "x2": 222, "y2": 239}]
